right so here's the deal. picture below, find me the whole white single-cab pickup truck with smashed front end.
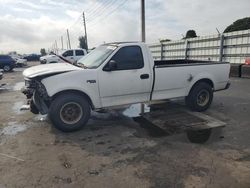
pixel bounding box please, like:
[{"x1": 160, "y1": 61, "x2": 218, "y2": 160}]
[{"x1": 23, "y1": 43, "x2": 230, "y2": 132}]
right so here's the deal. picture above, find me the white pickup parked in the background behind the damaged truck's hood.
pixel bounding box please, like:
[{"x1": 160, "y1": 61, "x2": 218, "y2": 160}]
[{"x1": 40, "y1": 49, "x2": 87, "y2": 64}]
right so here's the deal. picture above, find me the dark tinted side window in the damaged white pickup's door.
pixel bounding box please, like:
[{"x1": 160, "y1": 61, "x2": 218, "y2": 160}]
[{"x1": 112, "y1": 46, "x2": 144, "y2": 70}]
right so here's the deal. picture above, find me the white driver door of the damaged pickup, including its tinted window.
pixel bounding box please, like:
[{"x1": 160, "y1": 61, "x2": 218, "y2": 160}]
[{"x1": 98, "y1": 46, "x2": 152, "y2": 107}]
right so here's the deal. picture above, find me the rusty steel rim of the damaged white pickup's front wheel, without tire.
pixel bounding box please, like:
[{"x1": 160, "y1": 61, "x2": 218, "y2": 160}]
[{"x1": 60, "y1": 102, "x2": 83, "y2": 125}]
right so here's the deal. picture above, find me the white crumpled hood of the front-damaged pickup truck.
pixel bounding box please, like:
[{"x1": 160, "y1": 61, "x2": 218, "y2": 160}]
[{"x1": 23, "y1": 63, "x2": 82, "y2": 78}]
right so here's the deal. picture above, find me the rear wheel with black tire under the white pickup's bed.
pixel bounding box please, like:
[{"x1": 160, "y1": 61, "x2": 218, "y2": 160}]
[{"x1": 186, "y1": 82, "x2": 213, "y2": 112}]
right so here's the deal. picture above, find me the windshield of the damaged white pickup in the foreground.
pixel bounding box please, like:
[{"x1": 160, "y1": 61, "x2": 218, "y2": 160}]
[{"x1": 77, "y1": 45, "x2": 117, "y2": 69}]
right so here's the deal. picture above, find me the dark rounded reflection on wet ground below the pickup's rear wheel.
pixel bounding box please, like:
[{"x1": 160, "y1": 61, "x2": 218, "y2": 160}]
[{"x1": 187, "y1": 129, "x2": 212, "y2": 144}]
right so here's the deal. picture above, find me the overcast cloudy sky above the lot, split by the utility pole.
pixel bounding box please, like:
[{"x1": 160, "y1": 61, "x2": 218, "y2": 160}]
[{"x1": 0, "y1": 0, "x2": 250, "y2": 53}]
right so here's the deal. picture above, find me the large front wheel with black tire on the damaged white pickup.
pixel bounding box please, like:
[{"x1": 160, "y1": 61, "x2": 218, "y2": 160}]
[{"x1": 49, "y1": 93, "x2": 91, "y2": 132}]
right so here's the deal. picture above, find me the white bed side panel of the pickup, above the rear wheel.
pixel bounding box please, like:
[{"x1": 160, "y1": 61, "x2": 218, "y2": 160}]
[{"x1": 152, "y1": 64, "x2": 230, "y2": 100}]
